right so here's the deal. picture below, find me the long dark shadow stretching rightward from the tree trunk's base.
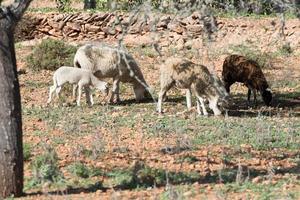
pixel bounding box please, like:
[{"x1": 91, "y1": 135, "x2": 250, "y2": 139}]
[{"x1": 25, "y1": 158, "x2": 300, "y2": 197}]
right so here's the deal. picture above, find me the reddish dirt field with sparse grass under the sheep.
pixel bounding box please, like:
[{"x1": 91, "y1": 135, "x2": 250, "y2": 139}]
[{"x1": 9, "y1": 2, "x2": 300, "y2": 199}]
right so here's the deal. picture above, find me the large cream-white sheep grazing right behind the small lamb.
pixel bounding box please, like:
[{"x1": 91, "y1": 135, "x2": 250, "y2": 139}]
[{"x1": 74, "y1": 43, "x2": 150, "y2": 103}]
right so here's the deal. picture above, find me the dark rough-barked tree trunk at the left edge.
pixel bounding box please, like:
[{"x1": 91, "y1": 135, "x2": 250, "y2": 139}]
[{"x1": 0, "y1": 0, "x2": 31, "y2": 199}]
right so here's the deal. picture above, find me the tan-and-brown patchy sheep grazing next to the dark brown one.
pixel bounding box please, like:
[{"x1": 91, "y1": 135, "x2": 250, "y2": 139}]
[{"x1": 157, "y1": 57, "x2": 228, "y2": 116}]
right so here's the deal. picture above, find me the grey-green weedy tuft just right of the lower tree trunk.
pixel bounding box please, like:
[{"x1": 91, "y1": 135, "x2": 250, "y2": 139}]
[{"x1": 26, "y1": 147, "x2": 64, "y2": 188}]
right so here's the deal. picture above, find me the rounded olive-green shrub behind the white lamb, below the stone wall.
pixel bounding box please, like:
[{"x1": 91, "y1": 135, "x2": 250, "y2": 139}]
[{"x1": 26, "y1": 39, "x2": 76, "y2": 71}]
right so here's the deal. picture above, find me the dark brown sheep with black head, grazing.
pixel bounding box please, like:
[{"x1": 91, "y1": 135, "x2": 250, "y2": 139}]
[{"x1": 222, "y1": 55, "x2": 272, "y2": 106}]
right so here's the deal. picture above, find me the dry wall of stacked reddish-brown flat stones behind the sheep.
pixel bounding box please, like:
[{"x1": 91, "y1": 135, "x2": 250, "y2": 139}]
[{"x1": 16, "y1": 13, "x2": 202, "y2": 41}]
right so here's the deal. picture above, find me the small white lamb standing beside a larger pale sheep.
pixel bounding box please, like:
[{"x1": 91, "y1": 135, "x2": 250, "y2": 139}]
[{"x1": 47, "y1": 66, "x2": 108, "y2": 106}]
